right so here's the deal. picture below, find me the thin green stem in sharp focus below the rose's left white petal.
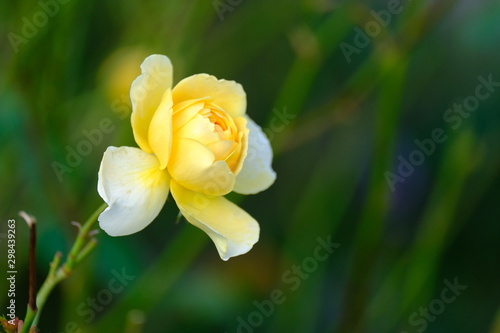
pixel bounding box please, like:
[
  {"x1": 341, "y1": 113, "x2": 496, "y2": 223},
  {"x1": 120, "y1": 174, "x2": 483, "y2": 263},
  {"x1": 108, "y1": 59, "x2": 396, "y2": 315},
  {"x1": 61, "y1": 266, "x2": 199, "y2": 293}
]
[{"x1": 21, "y1": 204, "x2": 107, "y2": 333}]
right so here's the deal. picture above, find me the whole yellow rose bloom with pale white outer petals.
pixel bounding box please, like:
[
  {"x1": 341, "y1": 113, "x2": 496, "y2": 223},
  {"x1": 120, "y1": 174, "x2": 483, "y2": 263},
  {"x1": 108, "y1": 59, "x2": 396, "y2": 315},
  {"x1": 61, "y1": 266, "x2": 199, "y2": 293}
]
[{"x1": 98, "y1": 55, "x2": 276, "y2": 260}]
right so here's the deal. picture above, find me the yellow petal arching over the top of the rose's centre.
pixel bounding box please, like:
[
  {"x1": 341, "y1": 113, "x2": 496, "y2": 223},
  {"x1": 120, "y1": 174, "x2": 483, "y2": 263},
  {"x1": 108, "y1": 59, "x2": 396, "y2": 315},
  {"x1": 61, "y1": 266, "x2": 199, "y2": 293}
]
[{"x1": 172, "y1": 74, "x2": 247, "y2": 118}]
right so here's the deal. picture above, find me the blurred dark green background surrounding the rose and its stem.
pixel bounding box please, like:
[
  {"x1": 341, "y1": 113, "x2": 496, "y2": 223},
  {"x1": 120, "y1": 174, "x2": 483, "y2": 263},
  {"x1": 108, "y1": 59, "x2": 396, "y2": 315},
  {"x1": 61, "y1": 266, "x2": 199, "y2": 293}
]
[{"x1": 0, "y1": 0, "x2": 500, "y2": 333}]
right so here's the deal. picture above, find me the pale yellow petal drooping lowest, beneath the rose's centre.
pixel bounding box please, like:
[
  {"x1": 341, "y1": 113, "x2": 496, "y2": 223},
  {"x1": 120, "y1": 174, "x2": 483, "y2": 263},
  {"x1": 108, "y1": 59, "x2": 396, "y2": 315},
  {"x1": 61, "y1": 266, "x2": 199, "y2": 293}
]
[{"x1": 171, "y1": 181, "x2": 260, "y2": 260}]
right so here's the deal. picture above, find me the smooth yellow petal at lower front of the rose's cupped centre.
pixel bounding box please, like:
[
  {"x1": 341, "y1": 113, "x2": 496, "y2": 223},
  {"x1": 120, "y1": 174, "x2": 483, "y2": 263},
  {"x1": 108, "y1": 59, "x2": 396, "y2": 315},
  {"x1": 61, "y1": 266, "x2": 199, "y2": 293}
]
[{"x1": 168, "y1": 139, "x2": 236, "y2": 195}]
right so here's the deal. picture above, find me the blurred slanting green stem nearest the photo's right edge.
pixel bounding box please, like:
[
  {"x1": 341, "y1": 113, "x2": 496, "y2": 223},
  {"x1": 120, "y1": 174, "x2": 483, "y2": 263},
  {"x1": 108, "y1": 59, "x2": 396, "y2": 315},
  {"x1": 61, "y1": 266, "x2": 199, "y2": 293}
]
[{"x1": 369, "y1": 131, "x2": 474, "y2": 331}]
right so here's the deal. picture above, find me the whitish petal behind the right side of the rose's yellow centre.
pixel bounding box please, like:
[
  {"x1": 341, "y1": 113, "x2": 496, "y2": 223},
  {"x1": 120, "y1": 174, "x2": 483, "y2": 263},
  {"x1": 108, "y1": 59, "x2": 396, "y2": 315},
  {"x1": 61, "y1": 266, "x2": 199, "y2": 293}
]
[{"x1": 233, "y1": 116, "x2": 276, "y2": 194}]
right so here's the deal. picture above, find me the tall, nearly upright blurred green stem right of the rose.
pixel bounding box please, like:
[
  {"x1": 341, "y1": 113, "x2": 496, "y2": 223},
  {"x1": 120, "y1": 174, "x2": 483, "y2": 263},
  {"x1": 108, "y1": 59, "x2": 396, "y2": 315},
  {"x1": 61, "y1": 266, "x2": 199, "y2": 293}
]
[{"x1": 339, "y1": 44, "x2": 407, "y2": 333}]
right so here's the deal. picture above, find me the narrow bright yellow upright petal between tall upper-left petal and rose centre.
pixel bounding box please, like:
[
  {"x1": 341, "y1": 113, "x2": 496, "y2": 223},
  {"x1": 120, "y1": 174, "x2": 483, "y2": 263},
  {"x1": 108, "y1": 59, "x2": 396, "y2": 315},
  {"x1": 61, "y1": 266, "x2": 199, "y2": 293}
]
[{"x1": 149, "y1": 89, "x2": 172, "y2": 169}]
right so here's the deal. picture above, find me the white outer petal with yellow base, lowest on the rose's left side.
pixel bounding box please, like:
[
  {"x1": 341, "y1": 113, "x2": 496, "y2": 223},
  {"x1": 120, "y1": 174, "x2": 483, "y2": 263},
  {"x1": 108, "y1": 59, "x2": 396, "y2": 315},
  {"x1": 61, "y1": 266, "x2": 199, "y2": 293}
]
[{"x1": 97, "y1": 147, "x2": 170, "y2": 236}]
